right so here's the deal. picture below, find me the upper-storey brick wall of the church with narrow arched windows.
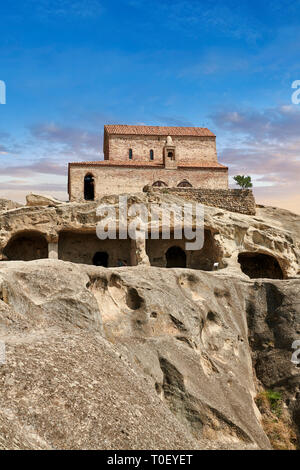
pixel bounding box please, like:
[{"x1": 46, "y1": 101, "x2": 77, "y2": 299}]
[{"x1": 104, "y1": 135, "x2": 217, "y2": 164}]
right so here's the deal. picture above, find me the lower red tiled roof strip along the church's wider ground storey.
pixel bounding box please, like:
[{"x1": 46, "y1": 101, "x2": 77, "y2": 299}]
[{"x1": 69, "y1": 160, "x2": 228, "y2": 169}]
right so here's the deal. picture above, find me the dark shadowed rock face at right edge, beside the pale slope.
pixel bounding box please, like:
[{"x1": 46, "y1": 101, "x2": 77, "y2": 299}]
[{"x1": 246, "y1": 280, "x2": 300, "y2": 439}]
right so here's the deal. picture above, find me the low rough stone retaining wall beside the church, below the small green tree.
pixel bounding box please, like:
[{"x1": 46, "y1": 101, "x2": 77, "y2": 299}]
[{"x1": 144, "y1": 187, "x2": 256, "y2": 215}]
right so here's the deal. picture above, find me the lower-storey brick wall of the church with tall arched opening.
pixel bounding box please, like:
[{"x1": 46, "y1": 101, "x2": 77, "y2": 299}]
[{"x1": 69, "y1": 164, "x2": 228, "y2": 202}]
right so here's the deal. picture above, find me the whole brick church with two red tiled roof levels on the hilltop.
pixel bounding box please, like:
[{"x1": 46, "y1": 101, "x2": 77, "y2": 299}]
[{"x1": 68, "y1": 125, "x2": 228, "y2": 201}]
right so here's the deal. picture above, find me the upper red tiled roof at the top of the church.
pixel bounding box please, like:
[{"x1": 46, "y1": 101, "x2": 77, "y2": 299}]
[{"x1": 104, "y1": 124, "x2": 215, "y2": 137}]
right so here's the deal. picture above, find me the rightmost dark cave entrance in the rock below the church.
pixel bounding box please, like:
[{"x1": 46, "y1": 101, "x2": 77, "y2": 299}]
[{"x1": 238, "y1": 252, "x2": 283, "y2": 279}]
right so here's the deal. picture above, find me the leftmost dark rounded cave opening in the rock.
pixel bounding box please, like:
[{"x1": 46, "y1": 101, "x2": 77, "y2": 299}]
[{"x1": 3, "y1": 230, "x2": 48, "y2": 261}]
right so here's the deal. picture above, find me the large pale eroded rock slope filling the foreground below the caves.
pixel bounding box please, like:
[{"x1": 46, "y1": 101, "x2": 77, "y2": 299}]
[{"x1": 0, "y1": 260, "x2": 300, "y2": 449}]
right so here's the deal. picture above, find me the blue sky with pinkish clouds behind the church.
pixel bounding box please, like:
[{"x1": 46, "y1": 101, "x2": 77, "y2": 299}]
[{"x1": 0, "y1": 0, "x2": 300, "y2": 212}]
